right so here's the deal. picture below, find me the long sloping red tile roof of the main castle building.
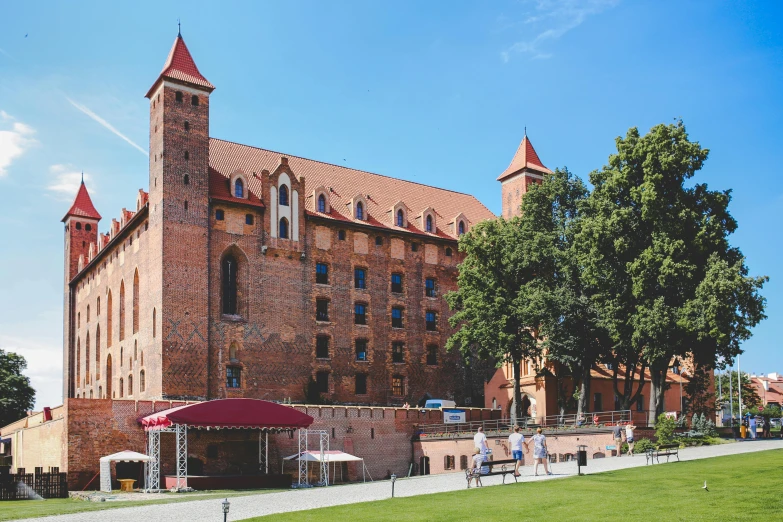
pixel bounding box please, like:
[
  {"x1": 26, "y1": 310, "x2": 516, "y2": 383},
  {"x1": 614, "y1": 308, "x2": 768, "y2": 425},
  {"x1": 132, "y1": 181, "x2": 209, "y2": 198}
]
[{"x1": 209, "y1": 138, "x2": 496, "y2": 239}]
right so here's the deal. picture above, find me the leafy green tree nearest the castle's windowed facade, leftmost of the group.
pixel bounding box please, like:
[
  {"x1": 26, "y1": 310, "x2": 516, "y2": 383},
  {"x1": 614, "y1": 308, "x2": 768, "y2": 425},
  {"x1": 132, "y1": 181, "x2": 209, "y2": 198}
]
[{"x1": 445, "y1": 217, "x2": 551, "y2": 418}]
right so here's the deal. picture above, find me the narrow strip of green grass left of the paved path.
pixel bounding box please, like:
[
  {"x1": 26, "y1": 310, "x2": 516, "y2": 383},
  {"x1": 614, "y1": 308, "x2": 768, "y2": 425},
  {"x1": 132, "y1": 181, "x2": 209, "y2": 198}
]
[{"x1": 0, "y1": 489, "x2": 279, "y2": 521}]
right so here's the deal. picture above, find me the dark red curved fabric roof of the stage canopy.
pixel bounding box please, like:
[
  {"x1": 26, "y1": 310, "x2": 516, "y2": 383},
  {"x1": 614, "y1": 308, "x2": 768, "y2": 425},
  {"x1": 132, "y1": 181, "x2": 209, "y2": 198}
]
[{"x1": 139, "y1": 399, "x2": 313, "y2": 431}]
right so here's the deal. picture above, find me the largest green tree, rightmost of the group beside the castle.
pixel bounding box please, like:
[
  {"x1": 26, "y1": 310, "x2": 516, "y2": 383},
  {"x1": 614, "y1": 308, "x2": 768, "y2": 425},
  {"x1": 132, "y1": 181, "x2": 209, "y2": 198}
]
[{"x1": 578, "y1": 121, "x2": 766, "y2": 423}]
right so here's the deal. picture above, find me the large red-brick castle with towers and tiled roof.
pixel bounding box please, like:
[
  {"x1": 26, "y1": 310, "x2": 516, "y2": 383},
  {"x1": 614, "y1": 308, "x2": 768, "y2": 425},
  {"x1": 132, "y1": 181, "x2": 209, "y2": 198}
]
[{"x1": 63, "y1": 36, "x2": 549, "y2": 406}]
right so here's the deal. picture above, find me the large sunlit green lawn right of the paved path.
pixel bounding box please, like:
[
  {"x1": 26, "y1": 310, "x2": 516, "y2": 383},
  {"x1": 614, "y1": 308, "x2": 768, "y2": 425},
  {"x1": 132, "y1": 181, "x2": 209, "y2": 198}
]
[{"x1": 251, "y1": 450, "x2": 783, "y2": 522}]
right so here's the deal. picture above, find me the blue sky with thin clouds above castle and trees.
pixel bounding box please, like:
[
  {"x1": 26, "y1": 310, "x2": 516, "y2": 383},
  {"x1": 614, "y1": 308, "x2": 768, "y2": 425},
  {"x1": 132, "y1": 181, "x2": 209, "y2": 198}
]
[{"x1": 0, "y1": 0, "x2": 783, "y2": 407}]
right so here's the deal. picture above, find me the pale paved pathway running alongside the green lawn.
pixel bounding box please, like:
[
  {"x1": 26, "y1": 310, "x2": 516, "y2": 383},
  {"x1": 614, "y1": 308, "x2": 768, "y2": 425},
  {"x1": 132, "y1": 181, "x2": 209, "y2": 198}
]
[{"x1": 21, "y1": 439, "x2": 783, "y2": 522}]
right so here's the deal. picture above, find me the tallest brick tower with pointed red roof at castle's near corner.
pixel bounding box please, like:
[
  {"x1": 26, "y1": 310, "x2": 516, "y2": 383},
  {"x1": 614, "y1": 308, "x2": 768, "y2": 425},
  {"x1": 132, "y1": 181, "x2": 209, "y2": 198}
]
[{"x1": 146, "y1": 34, "x2": 215, "y2": 398}]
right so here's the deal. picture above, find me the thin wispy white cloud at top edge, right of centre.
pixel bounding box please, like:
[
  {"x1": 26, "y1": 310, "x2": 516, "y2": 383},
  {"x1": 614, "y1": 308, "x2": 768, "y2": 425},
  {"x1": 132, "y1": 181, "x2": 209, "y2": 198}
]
[{"x1": 500, "y1": 0, "x2": 620, "y2": 62}]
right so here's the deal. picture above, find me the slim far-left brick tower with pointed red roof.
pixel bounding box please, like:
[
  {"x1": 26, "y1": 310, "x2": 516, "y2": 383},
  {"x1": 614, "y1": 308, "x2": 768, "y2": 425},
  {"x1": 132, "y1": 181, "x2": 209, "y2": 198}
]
[{"x1": 62, "y1": 180, "x2": 101, "y2": 398}]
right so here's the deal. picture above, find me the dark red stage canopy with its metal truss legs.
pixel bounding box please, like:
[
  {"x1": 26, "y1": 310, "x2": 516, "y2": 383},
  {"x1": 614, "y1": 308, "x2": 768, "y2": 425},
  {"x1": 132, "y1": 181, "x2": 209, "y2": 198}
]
[{"x1": 139, "y1": 398, "x2": 313, "y2": 490}]
